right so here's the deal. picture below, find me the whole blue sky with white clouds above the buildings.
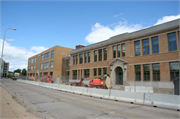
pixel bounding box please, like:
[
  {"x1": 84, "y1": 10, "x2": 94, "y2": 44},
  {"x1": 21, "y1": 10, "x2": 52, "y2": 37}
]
[{"x1": 0, "y1": 0, "x2": 180, "y2": 71}]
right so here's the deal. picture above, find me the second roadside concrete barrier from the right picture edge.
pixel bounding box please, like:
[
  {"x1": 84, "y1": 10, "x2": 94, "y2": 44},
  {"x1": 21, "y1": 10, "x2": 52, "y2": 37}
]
[{"x1": 109, "y1": 90, "x2": 144, "y2": 104}]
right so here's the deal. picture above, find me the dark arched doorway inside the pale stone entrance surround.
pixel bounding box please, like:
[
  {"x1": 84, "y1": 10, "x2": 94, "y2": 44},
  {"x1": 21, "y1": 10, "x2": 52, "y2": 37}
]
[{"x1": 116, "y1": 67, "x2": 123, "y2": 85}]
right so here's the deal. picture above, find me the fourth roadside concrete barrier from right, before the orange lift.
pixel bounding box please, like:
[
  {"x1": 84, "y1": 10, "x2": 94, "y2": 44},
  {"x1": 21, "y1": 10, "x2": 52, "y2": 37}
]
[{"x1": 71, "y1": 86, "x2": 88, "y2": 95}]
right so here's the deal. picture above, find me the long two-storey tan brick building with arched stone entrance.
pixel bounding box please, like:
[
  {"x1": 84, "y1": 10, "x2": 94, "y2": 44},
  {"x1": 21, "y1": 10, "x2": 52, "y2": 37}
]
[{"x1": 69, "y1": 19, "x2": 180, "y2": 93}]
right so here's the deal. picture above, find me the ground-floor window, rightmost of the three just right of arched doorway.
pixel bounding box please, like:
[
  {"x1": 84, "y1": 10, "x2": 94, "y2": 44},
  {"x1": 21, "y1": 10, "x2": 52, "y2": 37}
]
[{"x1": 152, "y1": 64, "x2": 160, "y2": 81}]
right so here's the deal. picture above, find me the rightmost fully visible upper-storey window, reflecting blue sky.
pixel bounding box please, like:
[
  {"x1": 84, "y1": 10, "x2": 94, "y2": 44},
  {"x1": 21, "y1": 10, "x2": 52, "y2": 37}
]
[{"x1": 168, "y1": 32, "x2": 177, "y2": 51}]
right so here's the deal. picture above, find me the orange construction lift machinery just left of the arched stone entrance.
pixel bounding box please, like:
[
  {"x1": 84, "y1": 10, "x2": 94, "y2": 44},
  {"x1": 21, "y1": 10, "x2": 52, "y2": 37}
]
[{"x1": 70, "y1": 75, "x2": 110, "y2": 89}]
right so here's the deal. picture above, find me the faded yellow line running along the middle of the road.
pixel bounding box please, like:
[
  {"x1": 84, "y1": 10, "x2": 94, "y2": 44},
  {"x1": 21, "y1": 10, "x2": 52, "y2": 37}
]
[{"x1": 29, "y1": 88, "x2": 142, "y2": 119}]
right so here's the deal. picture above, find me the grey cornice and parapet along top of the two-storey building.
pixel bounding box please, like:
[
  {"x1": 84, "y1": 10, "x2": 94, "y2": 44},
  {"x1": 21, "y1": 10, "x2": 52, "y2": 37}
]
[{"x1": 70, "y1": 19, "x2": 180, "y2": 55}]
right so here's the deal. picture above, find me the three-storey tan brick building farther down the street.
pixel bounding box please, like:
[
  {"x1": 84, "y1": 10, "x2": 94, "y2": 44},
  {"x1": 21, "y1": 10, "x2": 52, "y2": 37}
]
[{"x1": 27, "y1": 46, "x2": 73, "y2": 78}]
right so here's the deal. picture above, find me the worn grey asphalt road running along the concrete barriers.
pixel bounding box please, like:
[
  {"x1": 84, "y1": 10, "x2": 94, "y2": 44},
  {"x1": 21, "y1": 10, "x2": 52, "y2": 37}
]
[{"x1": 1, "y1": 79, "x2": 180, "y2": 119}]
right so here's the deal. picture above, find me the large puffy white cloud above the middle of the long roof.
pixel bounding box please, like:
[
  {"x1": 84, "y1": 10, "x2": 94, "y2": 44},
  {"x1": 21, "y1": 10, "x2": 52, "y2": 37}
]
[{"x1": 85, "y1": 20, "x2": 143, "y2": 43}]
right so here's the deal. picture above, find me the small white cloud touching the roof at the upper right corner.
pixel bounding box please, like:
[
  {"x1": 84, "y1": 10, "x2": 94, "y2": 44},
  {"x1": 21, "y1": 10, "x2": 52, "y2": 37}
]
[{"x1": 154, "y1": 14, "x2": 180, "y2": 25}]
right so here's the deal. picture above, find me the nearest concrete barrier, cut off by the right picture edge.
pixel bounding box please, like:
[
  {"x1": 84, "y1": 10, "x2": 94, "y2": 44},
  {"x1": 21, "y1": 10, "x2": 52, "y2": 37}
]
[{"x1": 143, "y1": 93, "x2": 180, "y2": 110}]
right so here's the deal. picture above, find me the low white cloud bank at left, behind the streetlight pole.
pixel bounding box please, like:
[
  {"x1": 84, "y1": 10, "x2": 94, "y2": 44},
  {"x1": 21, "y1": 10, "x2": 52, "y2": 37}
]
[{"x1": 0, "y1": 39, "x2": 47, "y2": 71}]
